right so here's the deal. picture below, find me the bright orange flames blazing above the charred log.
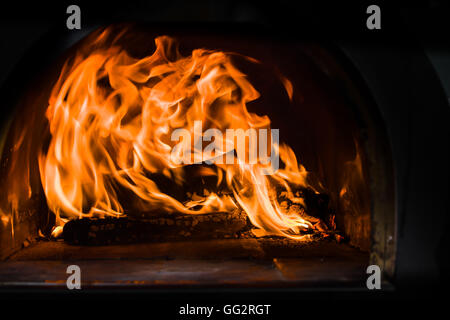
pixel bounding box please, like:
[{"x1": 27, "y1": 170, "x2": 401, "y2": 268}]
[{"x1": 39, "y1": 30, "x2": 330, "y2": 240}]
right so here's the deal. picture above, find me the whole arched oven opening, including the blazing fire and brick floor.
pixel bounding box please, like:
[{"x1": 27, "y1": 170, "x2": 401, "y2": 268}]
[{"x1": 0, "y1": 25, "x2": 395, "y2": 287}]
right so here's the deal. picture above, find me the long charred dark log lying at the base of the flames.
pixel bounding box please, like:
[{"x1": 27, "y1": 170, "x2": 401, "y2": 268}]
[{"x1": 63, "y1": 209, "x2": 249, "y2": 245}]
